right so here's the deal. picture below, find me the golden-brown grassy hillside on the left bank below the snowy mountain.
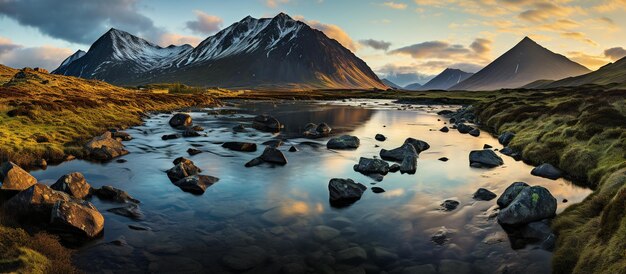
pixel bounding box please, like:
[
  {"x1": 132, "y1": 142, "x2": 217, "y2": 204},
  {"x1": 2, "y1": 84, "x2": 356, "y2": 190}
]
[{"x1": 0, "y1": 69, "x2": 215, "y2": 166}]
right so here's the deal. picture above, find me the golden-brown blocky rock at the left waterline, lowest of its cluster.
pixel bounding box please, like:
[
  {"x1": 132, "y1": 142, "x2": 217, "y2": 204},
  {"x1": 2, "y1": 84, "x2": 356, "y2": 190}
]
[{"x1": 50, "y1": 200, "x2": 104, "y2": 238}]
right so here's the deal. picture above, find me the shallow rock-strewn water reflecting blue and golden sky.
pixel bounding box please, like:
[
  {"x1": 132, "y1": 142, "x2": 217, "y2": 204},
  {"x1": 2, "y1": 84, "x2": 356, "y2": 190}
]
[{"x1": 33, "y1": 100, "x2": 590, "y2": 273}]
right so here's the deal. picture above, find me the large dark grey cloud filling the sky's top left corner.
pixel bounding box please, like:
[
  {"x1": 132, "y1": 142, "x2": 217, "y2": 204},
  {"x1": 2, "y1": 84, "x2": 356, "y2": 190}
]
[{"x1": 0, "y1": 0, "x2": 164, "y2": 44}]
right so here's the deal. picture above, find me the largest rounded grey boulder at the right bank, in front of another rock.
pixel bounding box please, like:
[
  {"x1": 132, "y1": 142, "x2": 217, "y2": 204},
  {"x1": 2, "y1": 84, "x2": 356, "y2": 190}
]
[{"x1": 498, "y1": 186, "x2": 556, "y2": 225}]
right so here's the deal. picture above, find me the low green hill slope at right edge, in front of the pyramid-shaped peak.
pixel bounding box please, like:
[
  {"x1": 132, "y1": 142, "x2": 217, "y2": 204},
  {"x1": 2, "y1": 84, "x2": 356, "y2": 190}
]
[{"x1": 537, "y1": 57, "x2": 626, "y2": 88}]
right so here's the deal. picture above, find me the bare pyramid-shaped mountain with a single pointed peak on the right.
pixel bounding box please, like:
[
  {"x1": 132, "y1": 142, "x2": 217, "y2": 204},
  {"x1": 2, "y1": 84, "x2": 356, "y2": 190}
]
[{"x1": 450, "y1": 37, "x2": 590, "y2": 90}]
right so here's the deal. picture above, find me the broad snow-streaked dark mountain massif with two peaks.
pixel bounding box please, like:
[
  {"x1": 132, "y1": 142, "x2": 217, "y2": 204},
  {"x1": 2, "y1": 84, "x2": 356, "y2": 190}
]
[{"x1": 54, "y1": 13, "x2": 386, "y2": 89}]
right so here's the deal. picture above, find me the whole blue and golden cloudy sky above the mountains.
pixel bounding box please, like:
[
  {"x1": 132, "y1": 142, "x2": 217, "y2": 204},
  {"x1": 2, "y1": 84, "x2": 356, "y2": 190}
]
[{"x1": 0, "y1": 0, "x2": 626, "y2": 85}]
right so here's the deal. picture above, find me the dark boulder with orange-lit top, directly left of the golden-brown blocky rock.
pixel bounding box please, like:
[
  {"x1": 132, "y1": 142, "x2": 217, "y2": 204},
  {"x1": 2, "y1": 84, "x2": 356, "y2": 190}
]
[{"x1": 3, "y1": 183, "x2": 70, "y2": 223}]
